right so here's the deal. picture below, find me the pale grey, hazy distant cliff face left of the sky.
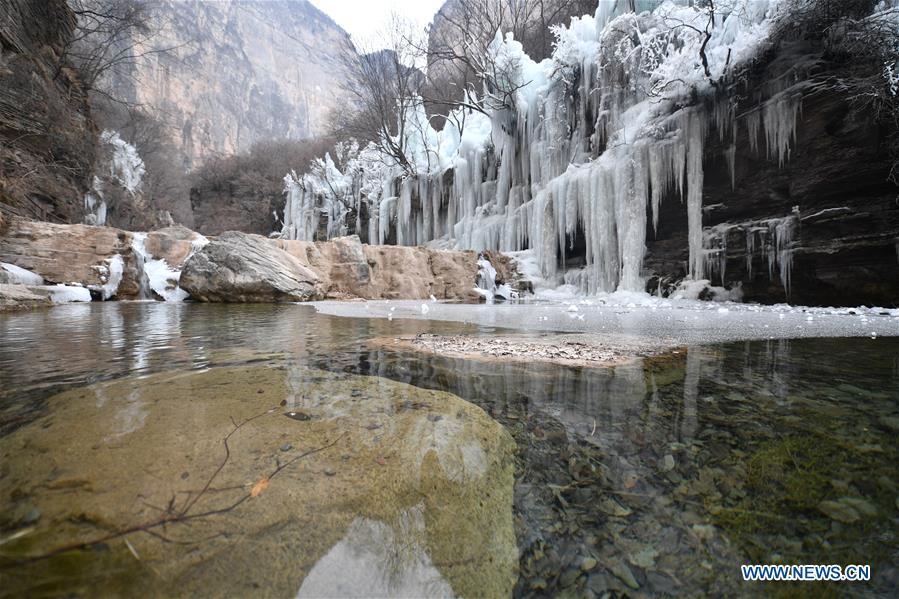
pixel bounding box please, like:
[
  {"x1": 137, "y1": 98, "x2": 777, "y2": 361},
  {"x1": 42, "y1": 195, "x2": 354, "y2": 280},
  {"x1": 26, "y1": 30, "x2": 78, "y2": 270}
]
[{"x1": 109, "y1": 0, "x2": 351, "y2": 168}]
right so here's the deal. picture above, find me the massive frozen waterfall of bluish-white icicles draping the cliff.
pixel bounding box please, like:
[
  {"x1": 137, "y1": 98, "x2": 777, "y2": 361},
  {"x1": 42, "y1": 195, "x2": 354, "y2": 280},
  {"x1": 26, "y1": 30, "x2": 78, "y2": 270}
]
[{"x1": 284, "y1": 0, "x2": 816, "y2": 292}]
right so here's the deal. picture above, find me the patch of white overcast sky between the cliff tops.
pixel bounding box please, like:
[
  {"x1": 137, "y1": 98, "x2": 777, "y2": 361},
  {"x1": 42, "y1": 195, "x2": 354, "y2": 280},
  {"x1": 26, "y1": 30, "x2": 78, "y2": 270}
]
[{"x1": 310, "y1": 0, "x2": 444, "y2": 48}]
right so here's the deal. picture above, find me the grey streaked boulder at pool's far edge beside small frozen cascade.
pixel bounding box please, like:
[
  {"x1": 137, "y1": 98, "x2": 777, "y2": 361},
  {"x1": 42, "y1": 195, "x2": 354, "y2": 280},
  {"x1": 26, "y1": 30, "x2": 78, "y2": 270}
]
[{"x1": 180, "y1": 231, "x2": 321, "y2": 302}]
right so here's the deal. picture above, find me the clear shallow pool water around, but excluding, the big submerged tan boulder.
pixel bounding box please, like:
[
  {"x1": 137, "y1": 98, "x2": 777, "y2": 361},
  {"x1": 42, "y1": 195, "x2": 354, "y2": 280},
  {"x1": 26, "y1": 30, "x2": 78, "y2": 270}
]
[{"x1": 0, "y1": 303, "x2": 899, "y2": 596}]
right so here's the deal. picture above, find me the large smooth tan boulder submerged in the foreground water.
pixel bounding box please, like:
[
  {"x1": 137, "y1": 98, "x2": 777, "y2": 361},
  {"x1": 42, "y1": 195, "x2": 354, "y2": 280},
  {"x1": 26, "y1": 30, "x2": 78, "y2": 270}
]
[{"x1": 0, "y1": 366, "x2": 518, "y2": 597}]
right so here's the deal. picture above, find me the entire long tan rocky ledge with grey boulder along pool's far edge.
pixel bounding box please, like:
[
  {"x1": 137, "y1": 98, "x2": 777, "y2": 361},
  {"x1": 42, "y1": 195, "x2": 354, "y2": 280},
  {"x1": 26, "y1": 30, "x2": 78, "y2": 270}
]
[{"x1": 0, "y1": 218, "x2": 515, "y2": 309}]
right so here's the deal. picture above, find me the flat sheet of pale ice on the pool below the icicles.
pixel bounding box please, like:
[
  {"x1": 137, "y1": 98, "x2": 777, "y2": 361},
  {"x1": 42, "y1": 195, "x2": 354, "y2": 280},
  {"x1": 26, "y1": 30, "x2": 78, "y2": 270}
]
[{"x1": 313, "y1": 293, "x2": 899, "y2": 347}]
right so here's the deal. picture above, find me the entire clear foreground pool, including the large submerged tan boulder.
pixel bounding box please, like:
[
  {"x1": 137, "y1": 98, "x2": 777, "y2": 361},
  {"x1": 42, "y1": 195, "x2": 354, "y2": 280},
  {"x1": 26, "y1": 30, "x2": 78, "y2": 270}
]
[{"x1": 0, "y1": 302, "x2": 899, "y2": 597}]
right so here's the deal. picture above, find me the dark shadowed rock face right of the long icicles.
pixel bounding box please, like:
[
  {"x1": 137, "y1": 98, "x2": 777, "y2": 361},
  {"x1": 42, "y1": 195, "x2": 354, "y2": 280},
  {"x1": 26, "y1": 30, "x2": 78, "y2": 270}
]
[{"x1": 645, "y1": 52, "x2": 899, "y2": 306}]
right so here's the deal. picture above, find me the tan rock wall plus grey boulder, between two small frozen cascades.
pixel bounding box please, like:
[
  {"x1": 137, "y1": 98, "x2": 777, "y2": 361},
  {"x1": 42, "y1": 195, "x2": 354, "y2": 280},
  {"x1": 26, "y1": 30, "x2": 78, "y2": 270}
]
[{"x1": 181, "y1": 231, "x2": 480, "y2": 302}]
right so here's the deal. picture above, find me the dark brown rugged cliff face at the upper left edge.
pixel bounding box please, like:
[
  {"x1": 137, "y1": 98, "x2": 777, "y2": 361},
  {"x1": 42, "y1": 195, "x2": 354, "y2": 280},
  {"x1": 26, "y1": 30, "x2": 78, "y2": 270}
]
[{"x1": 0, "y1": 0, "x2": 96, "y2": 222}]
